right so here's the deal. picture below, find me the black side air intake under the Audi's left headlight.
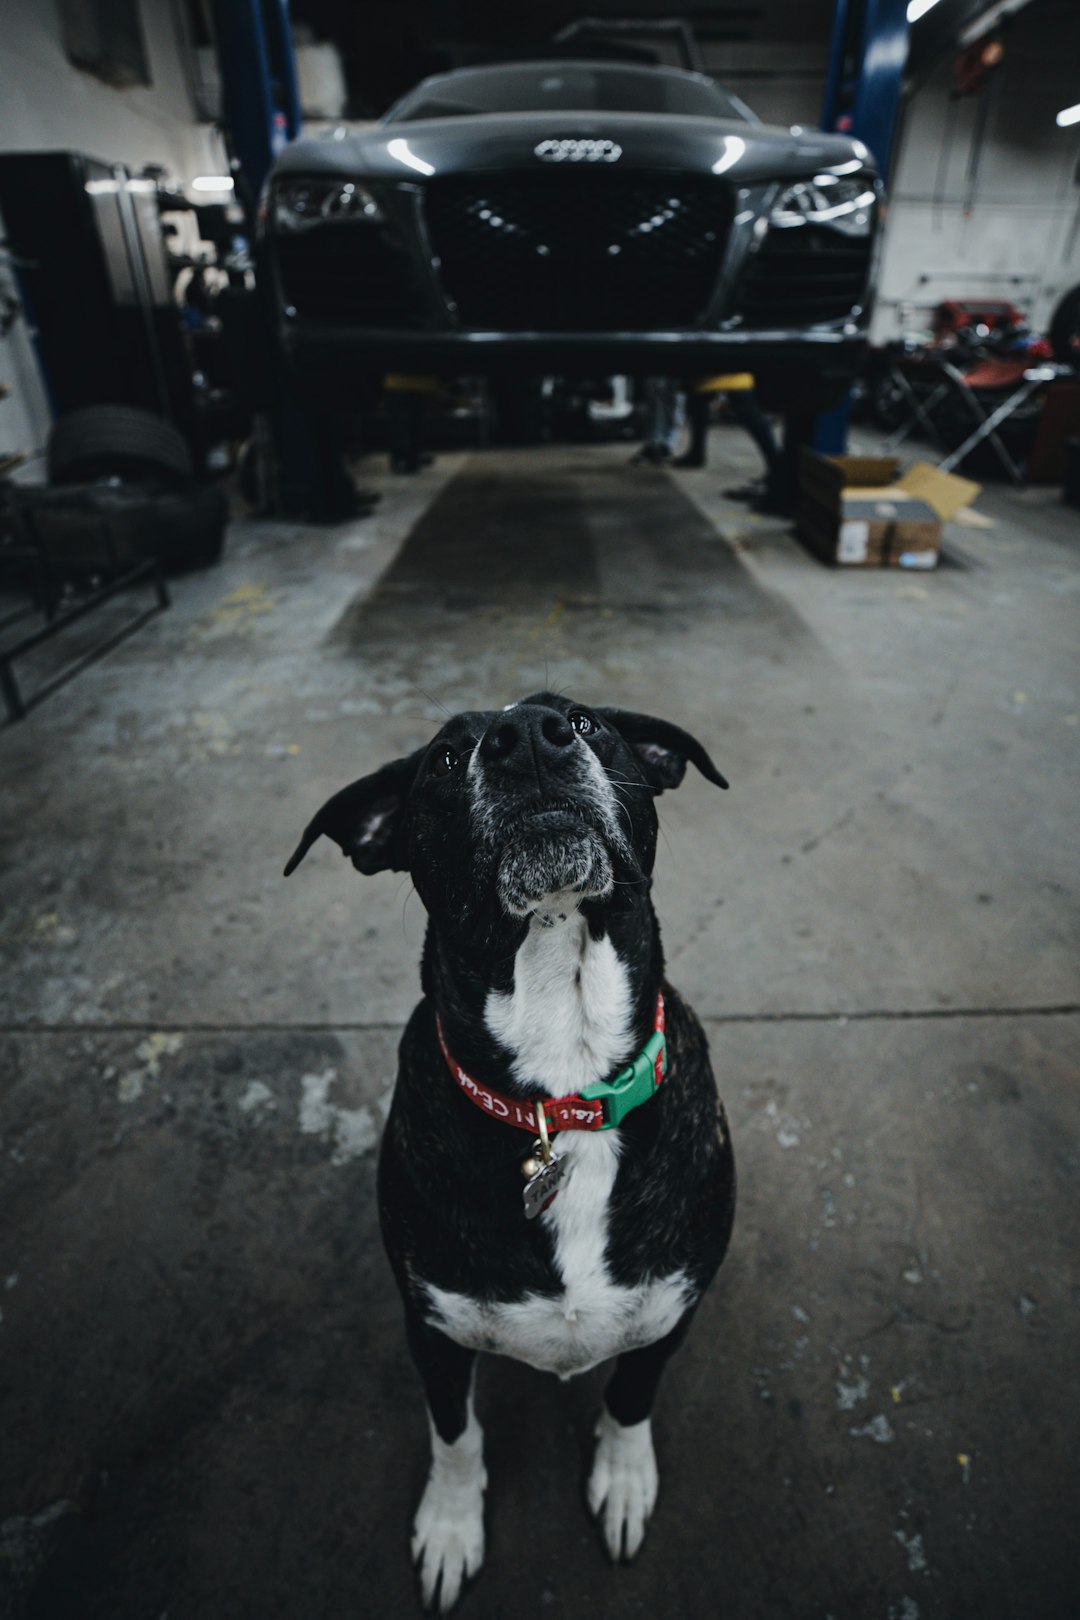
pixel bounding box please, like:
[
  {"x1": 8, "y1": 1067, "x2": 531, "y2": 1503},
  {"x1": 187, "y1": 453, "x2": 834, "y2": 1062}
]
[{"x1": 277, "y1": 222, "x2": 421, "y2": 327}]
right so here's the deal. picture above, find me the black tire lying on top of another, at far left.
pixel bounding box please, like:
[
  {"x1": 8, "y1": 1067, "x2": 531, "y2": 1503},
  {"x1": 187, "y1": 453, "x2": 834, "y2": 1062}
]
[{"x1": 49, "y1": 405, "x2": 191, "y2": 488}]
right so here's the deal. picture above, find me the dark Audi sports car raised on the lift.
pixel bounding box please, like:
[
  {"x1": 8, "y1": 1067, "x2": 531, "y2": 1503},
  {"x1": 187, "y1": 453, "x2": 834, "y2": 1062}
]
[{"x1": 264, "y1": 60, "x2": 881, "y2": 410}]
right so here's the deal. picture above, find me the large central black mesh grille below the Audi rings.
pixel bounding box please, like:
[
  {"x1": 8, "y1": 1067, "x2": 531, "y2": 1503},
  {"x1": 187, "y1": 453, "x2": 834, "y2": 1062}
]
[{"x1": 426, "y1": 168, "x2": 730, "y2": 332}]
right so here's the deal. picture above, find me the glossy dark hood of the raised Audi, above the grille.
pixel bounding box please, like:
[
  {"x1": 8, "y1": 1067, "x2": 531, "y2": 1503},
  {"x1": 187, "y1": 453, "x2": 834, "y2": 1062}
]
[{"x1": 274, "y1": 112, "x2": 874, "y2": 183}]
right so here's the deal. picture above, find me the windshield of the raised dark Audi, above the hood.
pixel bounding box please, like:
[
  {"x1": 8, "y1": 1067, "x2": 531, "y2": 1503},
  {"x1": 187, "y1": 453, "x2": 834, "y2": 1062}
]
[{"x1": 384, "y1": 62, "x2": 753, "y2": 123}]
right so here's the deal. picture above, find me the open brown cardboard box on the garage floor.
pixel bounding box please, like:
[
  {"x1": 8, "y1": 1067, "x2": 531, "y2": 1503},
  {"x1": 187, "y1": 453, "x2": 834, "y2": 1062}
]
[{"x1": 797, "y1": 450, "x2": 980, "y2": 569}]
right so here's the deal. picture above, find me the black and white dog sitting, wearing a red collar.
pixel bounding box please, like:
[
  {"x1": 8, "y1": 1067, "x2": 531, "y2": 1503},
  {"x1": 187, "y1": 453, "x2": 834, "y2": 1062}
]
[{"x1": 285, "y1": 692, "x2": 735, "y2": 1614}]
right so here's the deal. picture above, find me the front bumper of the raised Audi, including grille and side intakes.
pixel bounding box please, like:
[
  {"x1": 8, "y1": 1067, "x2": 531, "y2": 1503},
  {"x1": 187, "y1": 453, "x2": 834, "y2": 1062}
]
[{"x1": 266, "y1": 170, "x2": 873, "y2": 405}]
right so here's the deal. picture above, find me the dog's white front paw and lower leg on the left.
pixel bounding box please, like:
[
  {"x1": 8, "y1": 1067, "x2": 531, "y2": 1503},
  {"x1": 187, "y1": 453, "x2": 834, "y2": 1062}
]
[{"x1": 413, "y1": 1414, "x2": 487, "y2": 1615}]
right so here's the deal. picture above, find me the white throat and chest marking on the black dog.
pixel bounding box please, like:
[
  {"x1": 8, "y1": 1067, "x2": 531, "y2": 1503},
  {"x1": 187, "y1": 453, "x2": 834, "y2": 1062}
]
[{"x1": 427, "y1": 896, "x2": 693, "y2": 1379}]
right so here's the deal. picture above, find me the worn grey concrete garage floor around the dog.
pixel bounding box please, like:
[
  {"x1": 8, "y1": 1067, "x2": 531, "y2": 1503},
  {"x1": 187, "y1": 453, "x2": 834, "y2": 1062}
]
[{"x1": 0, "y1": 431, "x2": 1080, "y2": 1620}]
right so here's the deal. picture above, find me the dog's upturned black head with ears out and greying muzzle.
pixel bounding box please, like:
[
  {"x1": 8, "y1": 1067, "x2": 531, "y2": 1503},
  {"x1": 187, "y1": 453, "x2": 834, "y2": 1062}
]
[{"x1": 285, "y1": 692, "x2": 727, "y2": 927}]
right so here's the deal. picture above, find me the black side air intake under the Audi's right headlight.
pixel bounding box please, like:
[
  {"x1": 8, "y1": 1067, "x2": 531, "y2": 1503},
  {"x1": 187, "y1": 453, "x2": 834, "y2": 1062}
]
[{"x1": 733, "y1": 225, "x2": 871, "y2": 327}]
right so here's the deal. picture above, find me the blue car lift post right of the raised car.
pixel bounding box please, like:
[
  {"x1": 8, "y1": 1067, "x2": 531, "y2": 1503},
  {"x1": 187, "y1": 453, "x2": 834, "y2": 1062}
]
[{"x1": 803, "y1": 0, "x2": 908, "y2": 455}]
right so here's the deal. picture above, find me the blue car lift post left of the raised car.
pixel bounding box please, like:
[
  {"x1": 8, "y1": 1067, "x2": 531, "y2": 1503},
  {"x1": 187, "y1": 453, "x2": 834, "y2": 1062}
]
[{"x1": 210, "y1": 0, "x2": 355, "y2": 522}]
